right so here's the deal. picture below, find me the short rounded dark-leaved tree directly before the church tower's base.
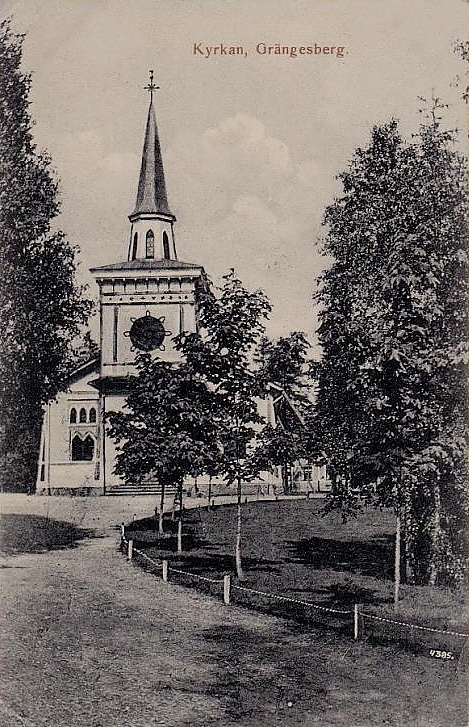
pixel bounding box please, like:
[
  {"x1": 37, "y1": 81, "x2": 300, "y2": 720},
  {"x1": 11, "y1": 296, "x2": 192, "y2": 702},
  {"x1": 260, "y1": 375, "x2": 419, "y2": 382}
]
[{"x1": 107, "y1": 353, "x2": 219, "y2": 550}]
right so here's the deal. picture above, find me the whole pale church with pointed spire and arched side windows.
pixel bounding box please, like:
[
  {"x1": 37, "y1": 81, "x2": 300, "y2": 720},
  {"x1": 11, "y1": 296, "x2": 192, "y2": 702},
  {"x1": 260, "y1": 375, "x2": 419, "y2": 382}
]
[{"x1": 36, "y1": 81, "x2": 330, "y2": 496}]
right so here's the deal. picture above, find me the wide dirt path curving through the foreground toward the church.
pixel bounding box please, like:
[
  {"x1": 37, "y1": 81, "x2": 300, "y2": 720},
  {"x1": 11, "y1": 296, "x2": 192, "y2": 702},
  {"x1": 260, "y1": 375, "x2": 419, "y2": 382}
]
[{"x1": 2, "y1": 498, "x2": 466, "y2": 727}]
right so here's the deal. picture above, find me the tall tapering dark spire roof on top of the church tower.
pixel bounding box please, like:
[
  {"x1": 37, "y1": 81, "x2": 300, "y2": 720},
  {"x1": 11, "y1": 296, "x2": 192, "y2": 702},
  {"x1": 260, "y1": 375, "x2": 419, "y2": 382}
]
[{"x1": 132, "y1": 101, "x2": 172, "y2": 217}]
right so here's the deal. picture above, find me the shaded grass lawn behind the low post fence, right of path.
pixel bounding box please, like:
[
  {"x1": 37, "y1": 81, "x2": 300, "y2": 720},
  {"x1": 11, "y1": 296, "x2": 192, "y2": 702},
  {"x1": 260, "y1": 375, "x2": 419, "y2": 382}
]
[{"x1": 132, "y1": 500, "x2": 467, "y2": 651}]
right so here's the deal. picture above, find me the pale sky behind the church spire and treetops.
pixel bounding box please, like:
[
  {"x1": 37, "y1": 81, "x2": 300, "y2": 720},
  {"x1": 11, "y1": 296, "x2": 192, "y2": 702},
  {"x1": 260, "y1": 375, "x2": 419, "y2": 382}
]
[{"x1": 3, "y1": 0, "x2": 469, "y2": 350}]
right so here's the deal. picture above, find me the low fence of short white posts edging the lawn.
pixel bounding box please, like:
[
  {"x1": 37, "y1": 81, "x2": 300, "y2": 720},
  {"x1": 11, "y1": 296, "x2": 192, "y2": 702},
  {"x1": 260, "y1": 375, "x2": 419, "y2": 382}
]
[{"x1": 120, "y1": 523, "x2": 468, "y2": 667}]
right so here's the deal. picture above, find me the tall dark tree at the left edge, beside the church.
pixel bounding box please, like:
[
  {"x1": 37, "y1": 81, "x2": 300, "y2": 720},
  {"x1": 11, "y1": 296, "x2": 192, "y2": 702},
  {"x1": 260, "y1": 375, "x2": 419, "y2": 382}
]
[{"x1": 0, "y1": 21, "x2": 90, "y2": 490}]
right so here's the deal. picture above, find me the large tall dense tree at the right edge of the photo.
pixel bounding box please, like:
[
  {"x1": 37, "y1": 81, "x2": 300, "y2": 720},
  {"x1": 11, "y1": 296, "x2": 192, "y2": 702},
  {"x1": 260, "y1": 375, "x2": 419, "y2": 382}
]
[{"x1": 315, "y1": 111, "x2": 467, "y2": 583}]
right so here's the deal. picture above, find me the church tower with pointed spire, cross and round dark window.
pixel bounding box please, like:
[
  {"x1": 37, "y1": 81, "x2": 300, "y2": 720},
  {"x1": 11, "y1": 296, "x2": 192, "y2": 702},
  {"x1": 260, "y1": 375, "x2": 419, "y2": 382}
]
[{"x1": 91, "y1": 71, "x2": 204, "y2": 492}]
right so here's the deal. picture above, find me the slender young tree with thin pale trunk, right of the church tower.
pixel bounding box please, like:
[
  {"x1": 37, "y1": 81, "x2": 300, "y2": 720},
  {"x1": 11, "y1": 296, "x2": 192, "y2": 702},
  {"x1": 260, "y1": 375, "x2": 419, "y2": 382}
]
[{"x1": 182, "y1": 269, "x2": 271, "y2": 579}]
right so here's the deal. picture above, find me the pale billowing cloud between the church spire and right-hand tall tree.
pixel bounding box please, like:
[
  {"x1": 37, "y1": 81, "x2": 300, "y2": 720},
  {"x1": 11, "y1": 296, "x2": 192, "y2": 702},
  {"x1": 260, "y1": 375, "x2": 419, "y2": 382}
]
[{"x1": 165, "y1": 113, "x2": 333, "y2": 338}]
